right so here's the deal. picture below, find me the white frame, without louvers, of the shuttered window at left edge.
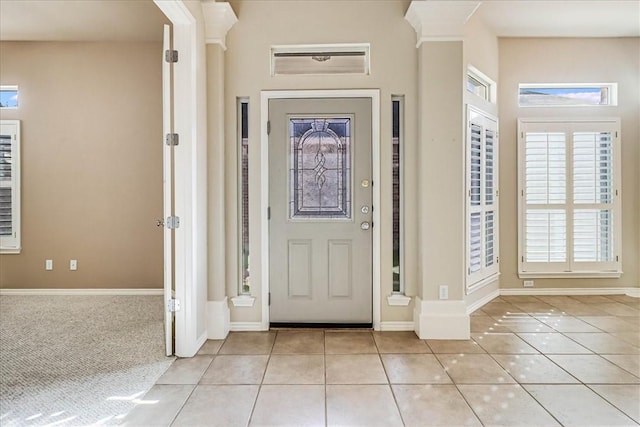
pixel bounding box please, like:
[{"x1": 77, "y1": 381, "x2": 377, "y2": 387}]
[{"x1": 0, "y1": 120, "x2": 22, "y2": 254}]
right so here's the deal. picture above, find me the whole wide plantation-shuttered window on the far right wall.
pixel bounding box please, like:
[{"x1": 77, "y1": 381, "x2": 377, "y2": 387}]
[{"x1": 518, "y1": 119, "x2": 622, "y2": 277}]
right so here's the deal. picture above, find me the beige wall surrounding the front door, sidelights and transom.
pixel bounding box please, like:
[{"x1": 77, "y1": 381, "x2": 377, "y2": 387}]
[{"x1": 225, "y1": 0, "x2": 417, "y2": 321}]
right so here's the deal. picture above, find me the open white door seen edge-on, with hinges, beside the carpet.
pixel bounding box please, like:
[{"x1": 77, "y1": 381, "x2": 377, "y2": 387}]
[{"x1": 162, "y1": 25, "x2": 174, "y2": 356}]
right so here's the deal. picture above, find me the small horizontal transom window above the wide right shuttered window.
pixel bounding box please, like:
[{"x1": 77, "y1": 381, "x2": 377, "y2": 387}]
[{"x1": 518, "y1": 83, "x2": 618, "y2": 107}]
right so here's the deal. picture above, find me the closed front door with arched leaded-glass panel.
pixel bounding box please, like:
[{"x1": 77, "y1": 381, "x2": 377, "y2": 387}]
[{"x1": 269, "y1": 98, "x2": 374, "y2": 324}]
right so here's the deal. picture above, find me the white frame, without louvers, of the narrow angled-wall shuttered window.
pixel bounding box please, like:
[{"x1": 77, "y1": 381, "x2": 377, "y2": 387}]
[{"x1": 465, "y1": 105, "x2": 500, "y2": 294}]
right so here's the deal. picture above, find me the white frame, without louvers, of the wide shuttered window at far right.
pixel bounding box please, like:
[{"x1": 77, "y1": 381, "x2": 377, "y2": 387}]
[{"x1": 518, "y1": 118, "x2": 622, "y2": 278}]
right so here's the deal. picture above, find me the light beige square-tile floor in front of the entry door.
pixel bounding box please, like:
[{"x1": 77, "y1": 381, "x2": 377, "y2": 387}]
[{"x1": 124, "y1": 296, "x2": 640, "y2": 427}]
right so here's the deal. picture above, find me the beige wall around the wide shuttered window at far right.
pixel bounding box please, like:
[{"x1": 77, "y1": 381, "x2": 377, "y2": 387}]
[{"x1": 498, "y1": 38, "x2": 640, "y2": 288}]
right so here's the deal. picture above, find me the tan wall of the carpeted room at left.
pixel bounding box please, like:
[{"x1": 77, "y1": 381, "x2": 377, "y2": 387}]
[{"x1": 0, "y1": 42, "x2": 163, "y2": 288}]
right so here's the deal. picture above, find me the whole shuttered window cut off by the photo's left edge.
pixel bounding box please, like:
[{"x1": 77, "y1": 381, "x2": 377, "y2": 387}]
[{"x1": 0, "y1": 120, "x2": 20, "y2": 253}]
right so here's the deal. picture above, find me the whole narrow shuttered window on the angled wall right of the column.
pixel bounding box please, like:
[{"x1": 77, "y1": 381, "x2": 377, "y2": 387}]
[{"x1": 466, "y1": 106, "x2": 498, "y2": 292}]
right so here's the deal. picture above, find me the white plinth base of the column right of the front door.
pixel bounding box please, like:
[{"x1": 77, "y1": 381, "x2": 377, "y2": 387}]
[{"x1": 413, "y1": 297, "x2": 471, "y2": 340}]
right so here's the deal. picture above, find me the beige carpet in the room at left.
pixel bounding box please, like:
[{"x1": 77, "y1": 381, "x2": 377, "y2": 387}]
[{"x1": 0, "y1": 295, "x2": 173, "y2": 427}]
